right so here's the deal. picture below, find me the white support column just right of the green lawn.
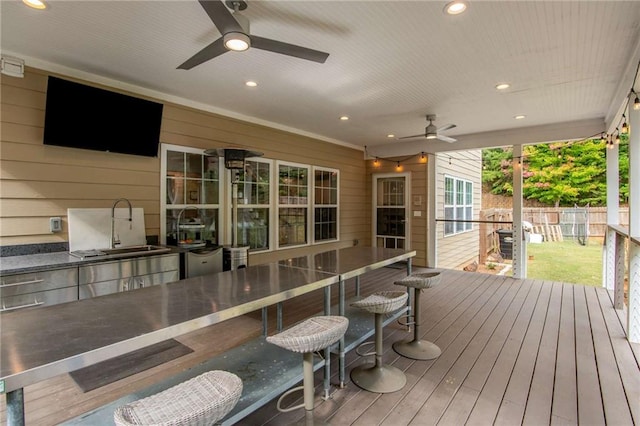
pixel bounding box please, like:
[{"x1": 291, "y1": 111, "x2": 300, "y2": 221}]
[{"x1": 602, "y1": 141, "x2": 624, "y2": 290}]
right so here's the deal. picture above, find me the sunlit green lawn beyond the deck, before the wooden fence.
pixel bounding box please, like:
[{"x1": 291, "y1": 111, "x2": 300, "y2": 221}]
[{"x1": 527, "y1": 238, "x2": 602, "y2": 286}]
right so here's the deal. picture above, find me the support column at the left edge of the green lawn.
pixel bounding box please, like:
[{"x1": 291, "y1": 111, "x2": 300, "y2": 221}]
[{"x1": 512, "y1": 145, "x2": 527, "y2": 278}]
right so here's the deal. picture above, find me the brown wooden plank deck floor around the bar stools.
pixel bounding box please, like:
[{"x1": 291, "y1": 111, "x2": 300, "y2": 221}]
[{"x1": 1, "y1": 268, "x2": 640, "y2": 426}]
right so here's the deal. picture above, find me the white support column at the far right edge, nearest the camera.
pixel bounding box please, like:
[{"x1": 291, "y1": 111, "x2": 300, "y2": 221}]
[{"x1": 627, "y1": 96, "x2": 640, "y2": 343}]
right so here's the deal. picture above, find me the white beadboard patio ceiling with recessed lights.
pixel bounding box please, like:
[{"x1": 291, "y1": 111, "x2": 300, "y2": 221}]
[{"x1": 0, "y1": 0, "x2": 640, "y2": 156}]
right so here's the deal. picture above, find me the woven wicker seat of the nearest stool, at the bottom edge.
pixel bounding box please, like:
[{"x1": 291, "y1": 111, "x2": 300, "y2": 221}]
[{"x1": 113, "y1": 370, "x2": 242, "y2": 426}]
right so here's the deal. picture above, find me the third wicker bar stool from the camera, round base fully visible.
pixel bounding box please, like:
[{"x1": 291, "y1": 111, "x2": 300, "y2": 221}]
[{"x1": 351, "y1": 291, "x2": 408, "y2": 393}]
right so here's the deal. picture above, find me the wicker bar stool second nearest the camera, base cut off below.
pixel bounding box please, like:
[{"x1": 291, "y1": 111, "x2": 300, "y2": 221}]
[{"x1": 267, "y1": 315, "x2": 349, "y2": 425}]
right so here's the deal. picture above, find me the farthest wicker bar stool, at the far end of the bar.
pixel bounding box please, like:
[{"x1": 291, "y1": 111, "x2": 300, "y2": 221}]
[{"x1": 393, "y1": 272, "x2": 442, "y2": 361}]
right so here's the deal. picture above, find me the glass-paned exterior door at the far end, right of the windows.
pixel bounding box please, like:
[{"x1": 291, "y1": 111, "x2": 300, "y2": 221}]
[{"x1": 373, "y1": 173, "x2": 410, "y2": 249}]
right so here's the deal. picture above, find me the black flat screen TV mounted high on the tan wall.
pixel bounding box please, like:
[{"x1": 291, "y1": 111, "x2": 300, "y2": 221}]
[{"x1": 44, "y1": 76, "x2": 163, "y2": 157}]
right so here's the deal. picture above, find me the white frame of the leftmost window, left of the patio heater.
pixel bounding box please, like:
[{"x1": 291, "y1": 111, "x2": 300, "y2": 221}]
[{"x1": 160, "y1": 143, "x2": 227, "y2": 245}]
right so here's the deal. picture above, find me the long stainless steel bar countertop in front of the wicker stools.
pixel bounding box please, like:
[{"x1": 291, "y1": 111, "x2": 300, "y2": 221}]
[{"x1": 0, "y1": 247, "x2": 415, "y2": 392}]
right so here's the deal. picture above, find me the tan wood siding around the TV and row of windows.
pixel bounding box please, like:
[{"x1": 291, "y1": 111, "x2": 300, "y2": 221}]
[{"x1": 0, "y1": 67, "x2": 371, "y2": 256}]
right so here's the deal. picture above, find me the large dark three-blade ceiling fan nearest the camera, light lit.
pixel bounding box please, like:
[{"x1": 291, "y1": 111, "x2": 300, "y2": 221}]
[{"x1": 178, "y1": 0, "x2": 329, "y2": 70}]
